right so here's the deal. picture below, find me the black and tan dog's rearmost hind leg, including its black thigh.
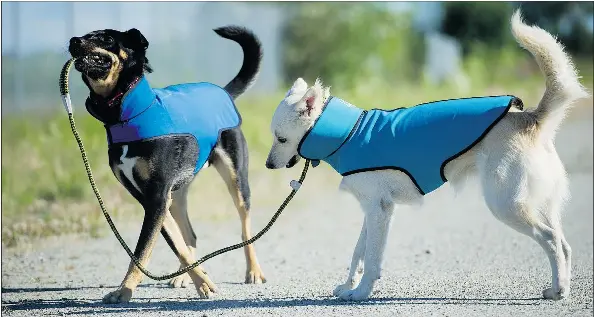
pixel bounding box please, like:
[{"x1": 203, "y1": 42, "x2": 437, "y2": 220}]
[{"x1": 213, "y1": 130, "x2": 266, "y2": 284}]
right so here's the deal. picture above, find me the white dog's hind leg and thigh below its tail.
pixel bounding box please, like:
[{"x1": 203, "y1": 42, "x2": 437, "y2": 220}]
[{"x1": 479, "y1": 146, "x2": 571, "y2": 300}]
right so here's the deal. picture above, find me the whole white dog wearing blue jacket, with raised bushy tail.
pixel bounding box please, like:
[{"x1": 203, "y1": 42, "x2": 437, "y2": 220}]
[{"x1": 266, "y1": 11, "x2": 588, "y2": 300}]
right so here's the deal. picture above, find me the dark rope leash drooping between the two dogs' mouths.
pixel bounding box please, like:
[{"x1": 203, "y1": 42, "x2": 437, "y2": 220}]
[{"x1": 60, "y1": 58, "x2": 310, "y2": 281}]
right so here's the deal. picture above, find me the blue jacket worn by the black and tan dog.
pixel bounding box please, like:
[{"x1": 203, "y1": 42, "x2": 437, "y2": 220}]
[{"x1": 105, "y1": 77, "x2": 241, "y2": 174}]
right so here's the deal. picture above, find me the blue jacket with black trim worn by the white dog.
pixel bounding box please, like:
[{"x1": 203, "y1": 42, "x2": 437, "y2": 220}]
[{"x1": 298, "y1": 96, "x2": 519, "y2": 195}]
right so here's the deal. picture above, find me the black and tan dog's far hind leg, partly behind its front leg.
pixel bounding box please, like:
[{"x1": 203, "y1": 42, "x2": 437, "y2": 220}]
[{"x1": 169, "y1": 184, "x2": 196, "y2": 288}]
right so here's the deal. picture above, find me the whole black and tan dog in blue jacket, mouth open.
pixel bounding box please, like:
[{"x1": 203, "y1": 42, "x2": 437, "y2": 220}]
[{"x1": 69, "y1": 26, "x2": 266, "y2": 303}]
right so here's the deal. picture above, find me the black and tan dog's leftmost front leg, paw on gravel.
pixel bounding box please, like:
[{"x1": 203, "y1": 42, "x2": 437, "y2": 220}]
[{"x1": 103, "y1": 189, "x2": 171, "y2": 304}]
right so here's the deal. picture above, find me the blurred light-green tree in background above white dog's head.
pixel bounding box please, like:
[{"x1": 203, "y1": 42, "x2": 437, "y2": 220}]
[{"x1": 281, "y1": 2, "x2": 424, "y2": 89}]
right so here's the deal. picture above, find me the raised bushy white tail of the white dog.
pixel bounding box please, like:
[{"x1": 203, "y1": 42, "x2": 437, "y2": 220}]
[{"x1": 511, "y1": 9, "x2": 589, "y2": 139}]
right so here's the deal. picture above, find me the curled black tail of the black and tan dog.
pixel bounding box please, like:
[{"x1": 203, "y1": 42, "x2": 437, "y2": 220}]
[{"x1": 214, "y1": 25, "x2": 262, "y2": 99}]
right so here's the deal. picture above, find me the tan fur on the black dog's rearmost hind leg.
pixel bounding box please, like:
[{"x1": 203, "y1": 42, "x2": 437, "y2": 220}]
[{"x1": 214, "y1": 151, "x2": 266, "y2": 284}]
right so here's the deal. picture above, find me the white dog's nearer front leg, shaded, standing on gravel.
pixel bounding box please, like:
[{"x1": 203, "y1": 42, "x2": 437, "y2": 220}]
[{"x1": 338, "y1": 201, "x2": 393, "y2": 300}]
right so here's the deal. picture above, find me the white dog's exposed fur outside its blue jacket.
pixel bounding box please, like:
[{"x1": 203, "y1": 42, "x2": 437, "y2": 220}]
[{"x1": 267, "y1": 11, "x2": 588, "y2": 300}]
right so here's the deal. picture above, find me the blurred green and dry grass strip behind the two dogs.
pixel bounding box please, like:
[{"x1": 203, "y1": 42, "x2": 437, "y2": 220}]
[{"x1": 2, "y1": 64, "x2": 592, "y2": 246}]
